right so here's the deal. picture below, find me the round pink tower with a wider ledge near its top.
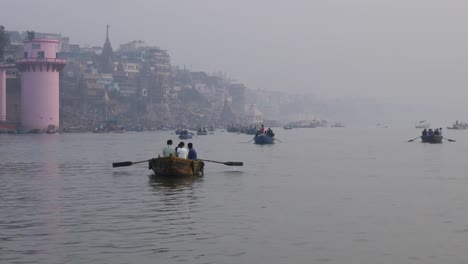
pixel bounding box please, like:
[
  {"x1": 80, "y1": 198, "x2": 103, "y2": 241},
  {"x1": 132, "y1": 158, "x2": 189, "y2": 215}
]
[{"x1": 16, "y1": 38, "x2": 66, "y2": 131}]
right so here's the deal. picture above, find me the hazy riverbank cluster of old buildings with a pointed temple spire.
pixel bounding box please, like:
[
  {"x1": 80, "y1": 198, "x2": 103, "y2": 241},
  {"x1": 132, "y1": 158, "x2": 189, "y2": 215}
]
[{"x1": 0, "y1": 26, "x2": 332, "y2": 130}]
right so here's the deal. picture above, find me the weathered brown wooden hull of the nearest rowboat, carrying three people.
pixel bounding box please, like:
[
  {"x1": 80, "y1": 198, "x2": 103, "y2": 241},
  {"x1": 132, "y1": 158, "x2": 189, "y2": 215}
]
[{"x1": 148, "y1": 156, "x2": 205, "y2": 177}]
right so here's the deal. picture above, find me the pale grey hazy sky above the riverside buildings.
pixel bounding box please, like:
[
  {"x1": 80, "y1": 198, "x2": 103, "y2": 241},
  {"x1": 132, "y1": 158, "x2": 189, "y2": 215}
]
[{"x1": 0, "y1": 0, "x2": 468, "y2": 109}]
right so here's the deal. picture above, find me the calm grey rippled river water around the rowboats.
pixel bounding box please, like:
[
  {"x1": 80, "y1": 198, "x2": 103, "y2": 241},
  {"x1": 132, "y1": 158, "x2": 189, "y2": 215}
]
[{"x1": 0, "y1": 128, "x2": 468, "y2": 264}]
